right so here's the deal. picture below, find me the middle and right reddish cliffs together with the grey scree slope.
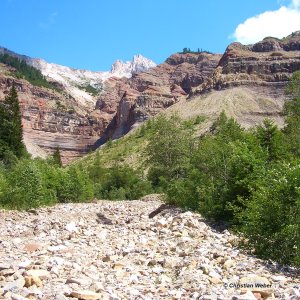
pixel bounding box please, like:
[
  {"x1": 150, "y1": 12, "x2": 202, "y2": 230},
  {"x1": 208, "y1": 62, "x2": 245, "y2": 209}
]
[{"x1": 102, "y1": 32, "x2": 300, "y2": 143}]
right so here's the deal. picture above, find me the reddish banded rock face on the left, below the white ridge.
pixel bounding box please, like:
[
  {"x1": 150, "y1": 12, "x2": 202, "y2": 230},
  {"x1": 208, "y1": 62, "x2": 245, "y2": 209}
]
[{"x1": 0, "y1": 72, "x2": 110, "y2": 163}]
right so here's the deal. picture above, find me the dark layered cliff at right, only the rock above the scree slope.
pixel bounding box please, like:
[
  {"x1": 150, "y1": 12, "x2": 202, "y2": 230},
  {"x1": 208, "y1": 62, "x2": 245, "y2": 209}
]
[{"x1": 192, "y1": 32, "x2": 300, "y2": 96}]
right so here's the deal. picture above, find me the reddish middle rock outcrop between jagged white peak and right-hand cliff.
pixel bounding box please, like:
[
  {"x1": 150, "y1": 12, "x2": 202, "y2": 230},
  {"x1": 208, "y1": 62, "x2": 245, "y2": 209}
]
[{"x1": 98, "y1": 52, "x2": 221, "y2": 142}]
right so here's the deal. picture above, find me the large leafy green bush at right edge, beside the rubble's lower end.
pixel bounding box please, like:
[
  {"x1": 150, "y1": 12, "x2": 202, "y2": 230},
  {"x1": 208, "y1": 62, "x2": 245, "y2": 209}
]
[{"x1": 238, "y1": 161, "x2": 300, "y2": 266}]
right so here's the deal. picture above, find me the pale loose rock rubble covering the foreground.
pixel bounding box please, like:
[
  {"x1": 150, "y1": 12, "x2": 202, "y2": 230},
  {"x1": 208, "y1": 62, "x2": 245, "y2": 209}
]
[{"x1": 0, "y1": 197, "x2": 300, "y2": 300}]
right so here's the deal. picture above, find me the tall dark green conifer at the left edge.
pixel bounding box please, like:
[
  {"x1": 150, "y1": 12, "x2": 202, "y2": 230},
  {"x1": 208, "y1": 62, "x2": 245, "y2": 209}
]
[{"x1": 0, "y1": 86, "x2": 25, "y2": 157}]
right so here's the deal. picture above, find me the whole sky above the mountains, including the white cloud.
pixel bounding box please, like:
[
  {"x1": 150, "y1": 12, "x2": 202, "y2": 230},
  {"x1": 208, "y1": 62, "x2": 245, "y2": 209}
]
[{"x1": 0, "y1": 0, "x2": 300, "y2": 71}]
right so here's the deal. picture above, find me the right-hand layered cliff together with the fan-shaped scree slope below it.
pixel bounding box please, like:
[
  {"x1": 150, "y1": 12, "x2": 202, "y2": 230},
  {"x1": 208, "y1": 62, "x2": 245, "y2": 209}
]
[{"x1": 173, "y1": 32, "x2": 300, "y2": 127}]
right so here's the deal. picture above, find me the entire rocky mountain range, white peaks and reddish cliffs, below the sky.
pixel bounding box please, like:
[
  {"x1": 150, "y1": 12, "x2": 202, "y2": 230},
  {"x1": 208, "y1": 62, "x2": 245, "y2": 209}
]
[{"x1": 0, "y1": 32, "x2": 300, "y2": 163}]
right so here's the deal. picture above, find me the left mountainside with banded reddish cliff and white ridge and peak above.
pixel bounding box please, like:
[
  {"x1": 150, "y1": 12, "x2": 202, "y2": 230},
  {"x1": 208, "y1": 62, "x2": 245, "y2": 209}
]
[{"x1": 0, "y1": 48, "x2": 155, "y2": 163}]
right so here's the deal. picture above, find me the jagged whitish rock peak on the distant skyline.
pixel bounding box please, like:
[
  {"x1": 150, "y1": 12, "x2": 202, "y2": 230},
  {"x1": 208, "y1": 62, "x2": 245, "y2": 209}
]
[{"x1": 111, "y1": 54, "x2": 156, "y2": 77}]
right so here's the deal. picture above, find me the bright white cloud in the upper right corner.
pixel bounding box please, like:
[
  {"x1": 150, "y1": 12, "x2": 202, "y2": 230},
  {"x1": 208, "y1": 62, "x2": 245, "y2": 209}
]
[{"x1": 233, "y1": 0, "x2": 300, "y2": 44}]
